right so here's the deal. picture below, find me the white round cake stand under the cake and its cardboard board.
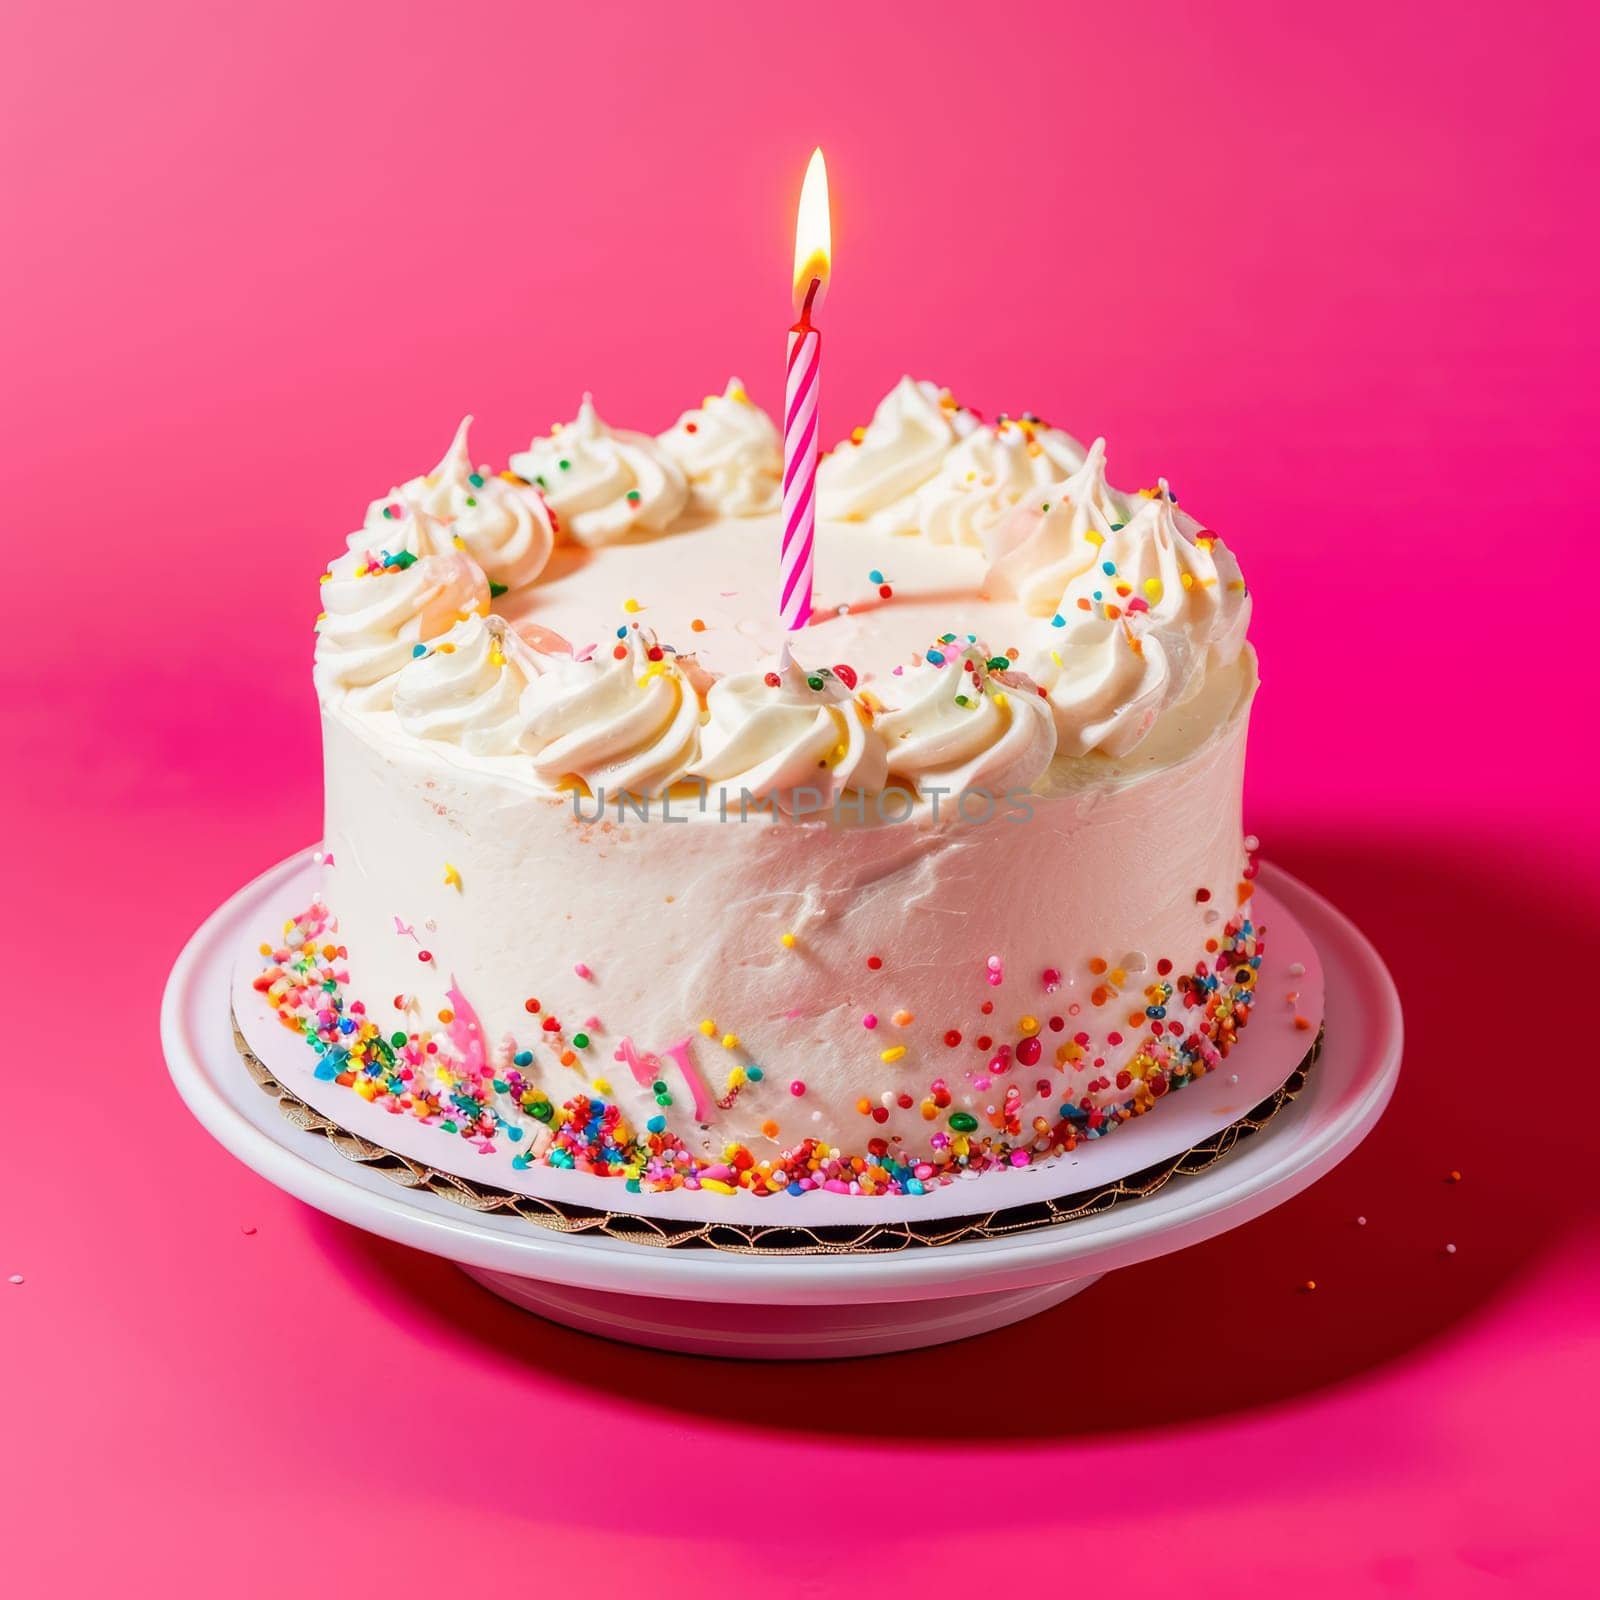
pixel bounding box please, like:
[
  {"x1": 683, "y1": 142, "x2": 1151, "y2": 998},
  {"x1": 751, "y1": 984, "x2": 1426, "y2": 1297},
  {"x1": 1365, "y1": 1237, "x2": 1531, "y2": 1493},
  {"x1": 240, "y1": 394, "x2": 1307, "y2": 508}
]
[{"x1": 162, "y1": 866, "x2": 1402, "y2": 1360}]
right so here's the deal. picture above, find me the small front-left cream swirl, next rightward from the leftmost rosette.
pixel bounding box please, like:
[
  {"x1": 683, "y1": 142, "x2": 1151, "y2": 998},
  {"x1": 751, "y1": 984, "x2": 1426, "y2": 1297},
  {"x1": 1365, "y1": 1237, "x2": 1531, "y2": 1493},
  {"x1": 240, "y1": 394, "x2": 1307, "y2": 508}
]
[{"x1": 395, "y1": 616, "x2": 539, "y2": 755}]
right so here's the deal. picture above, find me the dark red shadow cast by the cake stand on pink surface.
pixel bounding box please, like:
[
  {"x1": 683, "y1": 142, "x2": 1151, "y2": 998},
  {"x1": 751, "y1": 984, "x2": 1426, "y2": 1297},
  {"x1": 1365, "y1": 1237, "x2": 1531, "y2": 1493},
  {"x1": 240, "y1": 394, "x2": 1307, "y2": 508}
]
[{"x1": 309, "y1": 829, "x2": 1600, "y2": 1445}]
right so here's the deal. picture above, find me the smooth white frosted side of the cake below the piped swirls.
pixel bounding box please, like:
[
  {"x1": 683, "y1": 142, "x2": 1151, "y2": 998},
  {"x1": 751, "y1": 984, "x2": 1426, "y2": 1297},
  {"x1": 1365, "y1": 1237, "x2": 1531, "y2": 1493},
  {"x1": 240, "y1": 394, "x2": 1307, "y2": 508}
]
[{"x1": 308, "y1": 643, "x2": 1254, "y2": 1184}]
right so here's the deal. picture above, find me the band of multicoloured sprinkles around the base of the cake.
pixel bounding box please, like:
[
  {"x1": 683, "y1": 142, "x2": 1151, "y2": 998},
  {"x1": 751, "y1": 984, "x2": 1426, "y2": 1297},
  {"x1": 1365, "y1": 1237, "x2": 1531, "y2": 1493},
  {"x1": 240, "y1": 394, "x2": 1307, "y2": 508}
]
[{"x1": 254, "y1": 904, "x2": 1267, "y2": 1195}]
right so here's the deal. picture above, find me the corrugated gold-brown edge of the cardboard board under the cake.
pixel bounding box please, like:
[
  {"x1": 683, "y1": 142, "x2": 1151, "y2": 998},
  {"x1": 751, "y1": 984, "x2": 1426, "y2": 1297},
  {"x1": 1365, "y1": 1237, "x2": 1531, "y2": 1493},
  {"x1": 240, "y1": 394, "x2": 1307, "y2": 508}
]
[{"x1": 230, "y1": 1013, "x2": 1326, "y2": 1256}]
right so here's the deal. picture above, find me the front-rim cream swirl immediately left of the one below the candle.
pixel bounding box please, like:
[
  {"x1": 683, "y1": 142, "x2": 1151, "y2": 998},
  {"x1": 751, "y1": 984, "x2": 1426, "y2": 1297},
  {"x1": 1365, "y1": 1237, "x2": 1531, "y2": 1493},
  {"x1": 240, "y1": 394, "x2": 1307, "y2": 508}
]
[{"x1": 518, "y1": 627, "x2": 701, "y2": 798}]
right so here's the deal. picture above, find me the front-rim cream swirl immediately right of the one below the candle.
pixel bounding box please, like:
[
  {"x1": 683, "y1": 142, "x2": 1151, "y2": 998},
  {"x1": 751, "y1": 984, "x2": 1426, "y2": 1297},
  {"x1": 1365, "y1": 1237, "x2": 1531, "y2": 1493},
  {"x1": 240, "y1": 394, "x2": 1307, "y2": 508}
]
[{"x1": 877, "y1": 643, "x2": 1056, "y2": 797}]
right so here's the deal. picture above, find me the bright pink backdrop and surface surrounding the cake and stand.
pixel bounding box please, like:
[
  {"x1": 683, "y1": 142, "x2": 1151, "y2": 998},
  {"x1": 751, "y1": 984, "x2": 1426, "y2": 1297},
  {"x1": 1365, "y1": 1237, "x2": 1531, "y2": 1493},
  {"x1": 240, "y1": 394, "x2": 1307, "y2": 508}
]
[{"x1": 0, "y1": 0, "x2": 1600, "y2": 1600}]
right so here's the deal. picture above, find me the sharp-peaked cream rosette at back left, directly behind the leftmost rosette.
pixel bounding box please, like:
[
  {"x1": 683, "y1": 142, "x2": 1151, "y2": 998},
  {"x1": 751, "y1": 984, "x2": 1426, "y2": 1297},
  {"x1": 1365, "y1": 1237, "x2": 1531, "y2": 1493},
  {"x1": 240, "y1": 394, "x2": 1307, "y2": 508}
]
[{"x1": 350, "y1": 416, "x2": 555, "y2": 594}]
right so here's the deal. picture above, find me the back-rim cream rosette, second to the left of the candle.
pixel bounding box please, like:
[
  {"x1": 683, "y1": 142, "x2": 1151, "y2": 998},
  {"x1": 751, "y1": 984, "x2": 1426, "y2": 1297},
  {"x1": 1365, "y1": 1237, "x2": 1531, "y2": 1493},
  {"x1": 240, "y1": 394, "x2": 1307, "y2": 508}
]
[{"x1": 510, "y1": 395, "x2": 690, "y2": 546}]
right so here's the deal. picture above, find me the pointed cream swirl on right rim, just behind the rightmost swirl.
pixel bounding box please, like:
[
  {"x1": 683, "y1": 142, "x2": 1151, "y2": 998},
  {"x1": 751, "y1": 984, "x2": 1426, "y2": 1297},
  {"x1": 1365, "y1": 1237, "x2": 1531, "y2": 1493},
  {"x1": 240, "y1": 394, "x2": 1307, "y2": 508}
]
[{"x1": 982, "y1": 438, "x2": 1133, "y2": 616}]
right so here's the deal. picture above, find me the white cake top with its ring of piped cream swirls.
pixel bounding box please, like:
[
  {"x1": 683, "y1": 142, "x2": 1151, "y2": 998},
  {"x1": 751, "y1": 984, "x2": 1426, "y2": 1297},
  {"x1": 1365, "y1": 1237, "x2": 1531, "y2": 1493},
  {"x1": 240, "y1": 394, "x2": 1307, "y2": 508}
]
[{"x1": 317, "y1": 378, "x2": 1253, "y2": 797}]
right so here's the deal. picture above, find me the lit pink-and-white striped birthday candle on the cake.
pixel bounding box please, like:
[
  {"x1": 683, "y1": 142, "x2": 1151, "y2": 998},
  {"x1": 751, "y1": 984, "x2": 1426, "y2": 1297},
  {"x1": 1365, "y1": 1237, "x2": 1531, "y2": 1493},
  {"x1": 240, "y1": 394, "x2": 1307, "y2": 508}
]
[{"x1": 778, "y1": 150, "x2": 832, "y2": 632}]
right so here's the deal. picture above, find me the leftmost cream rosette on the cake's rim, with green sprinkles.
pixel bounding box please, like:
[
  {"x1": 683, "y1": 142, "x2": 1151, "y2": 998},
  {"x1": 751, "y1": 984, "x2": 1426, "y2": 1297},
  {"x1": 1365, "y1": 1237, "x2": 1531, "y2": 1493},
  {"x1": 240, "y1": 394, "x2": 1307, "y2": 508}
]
[{"x1": 317, "y1": 507, "x2": 490, "y2": 710}]
